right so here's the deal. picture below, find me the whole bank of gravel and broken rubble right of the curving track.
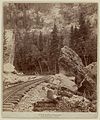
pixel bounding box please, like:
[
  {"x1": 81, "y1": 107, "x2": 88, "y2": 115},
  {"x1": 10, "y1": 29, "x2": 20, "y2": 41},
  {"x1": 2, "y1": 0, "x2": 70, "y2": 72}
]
[{"x1": 14, "y1": 75, "x2": 96, "y2": 112}]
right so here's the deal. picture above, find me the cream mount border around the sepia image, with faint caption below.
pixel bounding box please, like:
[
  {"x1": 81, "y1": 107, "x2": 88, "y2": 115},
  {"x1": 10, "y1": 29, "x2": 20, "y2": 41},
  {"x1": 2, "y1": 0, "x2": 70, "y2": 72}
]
[{"x1": 0, "y1": 0, "x2": 100, "y2": 119}]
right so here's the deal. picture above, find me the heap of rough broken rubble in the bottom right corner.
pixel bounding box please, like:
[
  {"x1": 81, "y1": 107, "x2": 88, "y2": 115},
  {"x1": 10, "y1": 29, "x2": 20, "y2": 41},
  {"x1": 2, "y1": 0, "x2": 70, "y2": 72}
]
[{"x1": 60, "y1": 95, "x2": 96, "y2": 112}]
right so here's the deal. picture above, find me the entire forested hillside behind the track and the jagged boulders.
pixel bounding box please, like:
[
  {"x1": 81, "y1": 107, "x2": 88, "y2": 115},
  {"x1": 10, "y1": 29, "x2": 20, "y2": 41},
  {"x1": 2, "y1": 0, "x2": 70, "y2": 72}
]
[{"x1": 4, "y1": 3, "x2": 97, "y2": 74}]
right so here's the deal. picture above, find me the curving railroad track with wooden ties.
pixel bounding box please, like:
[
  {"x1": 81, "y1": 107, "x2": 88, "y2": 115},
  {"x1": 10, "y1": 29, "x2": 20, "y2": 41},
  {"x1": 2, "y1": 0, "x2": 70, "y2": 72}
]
[{"x1": 3, "y1": 76, "x2": 50, "y2": 111}]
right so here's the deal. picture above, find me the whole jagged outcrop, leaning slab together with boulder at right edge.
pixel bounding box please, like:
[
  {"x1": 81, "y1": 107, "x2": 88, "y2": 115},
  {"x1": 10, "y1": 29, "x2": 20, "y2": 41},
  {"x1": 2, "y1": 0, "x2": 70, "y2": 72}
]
[{"x1": 59, "y1": 46, "x2": 97, "y2": 100}]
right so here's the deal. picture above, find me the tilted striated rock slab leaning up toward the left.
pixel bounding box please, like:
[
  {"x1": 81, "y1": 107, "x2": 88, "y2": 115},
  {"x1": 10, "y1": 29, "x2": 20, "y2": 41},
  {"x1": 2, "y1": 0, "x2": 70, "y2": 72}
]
[{"x1": 59, "y1": 46, "x2": 87, "y2": 84}]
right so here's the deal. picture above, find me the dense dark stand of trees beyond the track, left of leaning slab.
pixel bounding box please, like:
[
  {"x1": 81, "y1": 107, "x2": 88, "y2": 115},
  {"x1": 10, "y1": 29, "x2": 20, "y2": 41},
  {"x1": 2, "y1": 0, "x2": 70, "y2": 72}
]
[{"x1": 14, "y1": 25, "x2": 63, "y2": 74}]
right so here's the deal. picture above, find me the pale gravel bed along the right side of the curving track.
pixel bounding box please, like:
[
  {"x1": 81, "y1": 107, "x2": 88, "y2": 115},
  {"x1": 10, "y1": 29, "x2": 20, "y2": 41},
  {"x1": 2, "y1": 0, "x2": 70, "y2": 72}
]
[{"x1": 13, "y1": 83, "x2": 48, "y2": 112}]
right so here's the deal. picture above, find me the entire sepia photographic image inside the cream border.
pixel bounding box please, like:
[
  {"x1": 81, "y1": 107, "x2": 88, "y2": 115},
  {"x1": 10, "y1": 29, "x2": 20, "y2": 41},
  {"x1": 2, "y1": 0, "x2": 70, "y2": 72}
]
[{"x1": 2, "y1": 3, "x2": 98, "y2": 112}]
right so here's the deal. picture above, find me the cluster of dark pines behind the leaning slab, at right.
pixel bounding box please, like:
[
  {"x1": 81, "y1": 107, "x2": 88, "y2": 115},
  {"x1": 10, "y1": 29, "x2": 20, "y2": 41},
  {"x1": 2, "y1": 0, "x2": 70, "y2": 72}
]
[{"x1": 70, "y1": 12, "x2": 97, "y2": 66}]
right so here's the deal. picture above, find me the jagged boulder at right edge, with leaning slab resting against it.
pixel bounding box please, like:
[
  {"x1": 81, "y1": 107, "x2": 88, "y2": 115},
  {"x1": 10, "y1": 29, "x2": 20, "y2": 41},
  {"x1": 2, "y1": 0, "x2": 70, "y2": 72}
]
[{"x1": 79, "y1": 62, "x2": 97, "y2": 101}]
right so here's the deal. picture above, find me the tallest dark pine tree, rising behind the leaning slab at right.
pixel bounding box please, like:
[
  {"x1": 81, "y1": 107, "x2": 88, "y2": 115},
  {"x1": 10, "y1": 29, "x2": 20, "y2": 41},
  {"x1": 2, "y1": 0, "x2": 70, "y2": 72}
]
[{"x1": 74, "y1": 12, "x2": 91, "y2": 66}]
